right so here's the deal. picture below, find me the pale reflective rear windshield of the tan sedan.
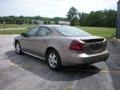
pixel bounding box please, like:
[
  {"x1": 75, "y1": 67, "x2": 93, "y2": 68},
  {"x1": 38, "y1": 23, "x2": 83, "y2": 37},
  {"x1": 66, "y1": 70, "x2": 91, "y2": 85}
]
[{"x1": 55, "y1": 26, "x2": 90, "y2": 37}]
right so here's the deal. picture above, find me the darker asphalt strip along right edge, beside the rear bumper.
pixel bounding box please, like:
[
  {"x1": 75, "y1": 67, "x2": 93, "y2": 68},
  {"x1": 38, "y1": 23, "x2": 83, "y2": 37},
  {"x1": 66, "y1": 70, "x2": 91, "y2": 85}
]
[{"x1": 106, "y1": 40, "x2": 120, "y2": 90}]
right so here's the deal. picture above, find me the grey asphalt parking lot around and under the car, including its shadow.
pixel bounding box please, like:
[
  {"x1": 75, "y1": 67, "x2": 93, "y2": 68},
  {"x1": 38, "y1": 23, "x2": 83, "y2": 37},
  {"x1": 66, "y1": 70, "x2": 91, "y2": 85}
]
[{"x1": 0, "y1": 35, "x2": 120, "y2": 90}]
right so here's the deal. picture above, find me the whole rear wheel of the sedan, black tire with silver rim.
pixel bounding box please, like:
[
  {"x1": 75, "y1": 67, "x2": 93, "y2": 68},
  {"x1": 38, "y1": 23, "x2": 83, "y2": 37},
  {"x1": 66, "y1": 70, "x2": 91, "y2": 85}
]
[{"x1": 46, "y1": 49, "x2": 62, "y2": 71}]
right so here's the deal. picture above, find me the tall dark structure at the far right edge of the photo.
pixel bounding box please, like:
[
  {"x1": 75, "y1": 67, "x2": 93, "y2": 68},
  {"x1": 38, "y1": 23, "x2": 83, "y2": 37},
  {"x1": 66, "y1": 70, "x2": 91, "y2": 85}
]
[{"x1": 116, "y1": 0, "x2": 120, "y2": 38}]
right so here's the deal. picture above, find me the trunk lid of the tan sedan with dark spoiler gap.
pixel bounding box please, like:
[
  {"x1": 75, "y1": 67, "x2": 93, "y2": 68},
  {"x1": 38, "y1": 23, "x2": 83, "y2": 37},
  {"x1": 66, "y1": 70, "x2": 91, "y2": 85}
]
[{"x1": 79, "y1": 36, "x2": 107, "y2": 54}]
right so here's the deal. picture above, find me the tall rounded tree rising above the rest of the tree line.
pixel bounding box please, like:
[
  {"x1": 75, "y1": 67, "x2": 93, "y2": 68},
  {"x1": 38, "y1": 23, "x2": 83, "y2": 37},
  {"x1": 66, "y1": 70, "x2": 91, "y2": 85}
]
[{"x1": 67, "y1": 7, "x2": 78, "y2": 26}]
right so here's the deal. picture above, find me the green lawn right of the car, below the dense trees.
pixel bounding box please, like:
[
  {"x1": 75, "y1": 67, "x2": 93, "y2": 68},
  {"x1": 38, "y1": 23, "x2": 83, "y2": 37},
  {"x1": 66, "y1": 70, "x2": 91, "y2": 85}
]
[{"x1": 78, "y1": 27, "x2": 115, "y2": 39}]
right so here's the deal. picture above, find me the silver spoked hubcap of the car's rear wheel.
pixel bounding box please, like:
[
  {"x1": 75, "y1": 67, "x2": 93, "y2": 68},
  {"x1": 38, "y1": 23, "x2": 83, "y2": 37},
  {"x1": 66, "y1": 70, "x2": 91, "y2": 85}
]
[{"x1": 48, "y1": 53, "x2": 57, "y2": 68}]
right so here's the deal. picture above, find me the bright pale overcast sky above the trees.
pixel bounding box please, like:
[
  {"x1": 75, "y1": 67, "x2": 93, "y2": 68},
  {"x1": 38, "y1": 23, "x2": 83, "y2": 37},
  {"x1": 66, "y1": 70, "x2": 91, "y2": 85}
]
[{"x1": 0, "y1": 0, "x2": 118, "y2": 17}]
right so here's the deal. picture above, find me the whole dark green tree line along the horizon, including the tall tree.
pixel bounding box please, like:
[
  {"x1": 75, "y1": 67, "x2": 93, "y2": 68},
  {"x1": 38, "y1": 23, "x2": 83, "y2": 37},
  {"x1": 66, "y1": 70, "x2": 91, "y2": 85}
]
[{"x1": 0, "y1": 7, "x2": 117, "y2": 27}]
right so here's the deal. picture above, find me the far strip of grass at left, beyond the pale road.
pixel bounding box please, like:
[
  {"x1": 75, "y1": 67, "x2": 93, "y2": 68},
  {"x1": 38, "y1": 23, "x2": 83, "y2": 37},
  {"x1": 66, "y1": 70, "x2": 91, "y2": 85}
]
[{"x1": 0, "y1": 24, "x2": 34, "y2": 29}]
